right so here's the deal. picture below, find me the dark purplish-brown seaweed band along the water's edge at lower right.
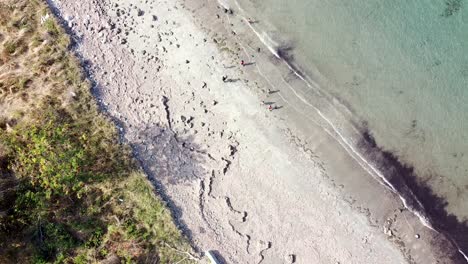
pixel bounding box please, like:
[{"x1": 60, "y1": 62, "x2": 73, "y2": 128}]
[{"x1": 358, "y1": 126, "x2": 468, "y2": 263}]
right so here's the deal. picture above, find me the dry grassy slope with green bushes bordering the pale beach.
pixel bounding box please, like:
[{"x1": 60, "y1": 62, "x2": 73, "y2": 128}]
[{"x1": 0, "y1": 0, "x2": 196, "y2": 263}]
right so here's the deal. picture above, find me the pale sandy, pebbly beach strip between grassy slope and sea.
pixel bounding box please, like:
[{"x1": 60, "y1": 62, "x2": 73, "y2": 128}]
[{"x1": 45, "y1": 0, "x2": 460, "y2": 264}]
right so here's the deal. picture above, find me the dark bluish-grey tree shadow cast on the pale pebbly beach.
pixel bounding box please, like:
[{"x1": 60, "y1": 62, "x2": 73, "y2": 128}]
[{"x1": 130, "y1": 122, "x2": 209, "y2": 251}]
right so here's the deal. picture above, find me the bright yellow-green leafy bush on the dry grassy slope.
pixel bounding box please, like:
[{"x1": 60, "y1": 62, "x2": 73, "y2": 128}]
[{"x1": 4, "y1": 111, "x2": 92, "y2": 221}]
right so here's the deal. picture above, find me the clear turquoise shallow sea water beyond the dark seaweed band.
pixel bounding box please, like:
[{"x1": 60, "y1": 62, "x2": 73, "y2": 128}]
[{"x1": 234, "y1": 0, "x2": 468, "y2": 223}]
